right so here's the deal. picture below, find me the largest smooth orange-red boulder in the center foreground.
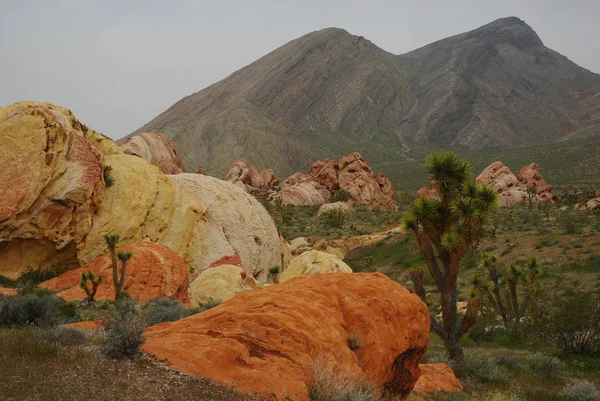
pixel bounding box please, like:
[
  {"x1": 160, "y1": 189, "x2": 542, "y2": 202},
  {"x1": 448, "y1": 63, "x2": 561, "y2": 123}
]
[{"x1": 142, "y1": 273, "x2": 429, "y2": 401}]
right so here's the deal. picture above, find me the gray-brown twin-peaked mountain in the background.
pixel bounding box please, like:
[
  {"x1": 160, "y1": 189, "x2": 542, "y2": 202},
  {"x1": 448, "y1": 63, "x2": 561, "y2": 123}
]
[{"x1": 129, "y1": 17, "x2": 600, "y2": 184}]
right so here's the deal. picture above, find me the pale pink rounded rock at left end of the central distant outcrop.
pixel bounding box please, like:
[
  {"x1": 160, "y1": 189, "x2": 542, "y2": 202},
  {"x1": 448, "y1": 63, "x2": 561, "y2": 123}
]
[{"x1": 277, "y1": 173, "x2": 331, "y2": 206}]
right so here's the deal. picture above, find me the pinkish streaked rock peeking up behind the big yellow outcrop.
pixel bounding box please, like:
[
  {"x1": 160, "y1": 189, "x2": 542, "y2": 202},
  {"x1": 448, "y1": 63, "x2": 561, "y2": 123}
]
[{"x1": 120, "y1": 132, "x2": 183, "y2": 174}]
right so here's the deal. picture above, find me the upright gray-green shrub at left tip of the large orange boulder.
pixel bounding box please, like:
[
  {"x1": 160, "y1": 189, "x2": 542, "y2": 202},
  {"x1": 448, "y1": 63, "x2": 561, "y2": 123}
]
[{"x1": 102, "y1": 299, "x2": 146, "y2": 359}]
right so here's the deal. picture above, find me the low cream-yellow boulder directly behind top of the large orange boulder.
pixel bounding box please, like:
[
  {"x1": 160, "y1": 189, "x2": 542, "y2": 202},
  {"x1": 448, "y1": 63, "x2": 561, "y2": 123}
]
[{"x1": 279, "y1": 250, "x2": 352, "y2": 283}]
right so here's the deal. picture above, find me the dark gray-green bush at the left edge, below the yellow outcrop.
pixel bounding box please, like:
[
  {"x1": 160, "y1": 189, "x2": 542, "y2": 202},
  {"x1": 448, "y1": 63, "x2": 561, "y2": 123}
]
[{"x1": 0, "y1": 288, "x2": 77, "y2": 326}]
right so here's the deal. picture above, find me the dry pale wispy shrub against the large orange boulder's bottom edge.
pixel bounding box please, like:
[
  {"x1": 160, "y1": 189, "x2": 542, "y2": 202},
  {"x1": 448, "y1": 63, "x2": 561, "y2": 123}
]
[{"x1": 308, "y1": 359, "x2": 379, "y2": 401}]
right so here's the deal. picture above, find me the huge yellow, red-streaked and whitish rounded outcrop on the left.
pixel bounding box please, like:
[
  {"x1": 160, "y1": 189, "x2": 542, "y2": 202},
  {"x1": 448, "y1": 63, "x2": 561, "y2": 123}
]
[{"x1": 0, "y1": 103, "x2": 282, "y2": 278}]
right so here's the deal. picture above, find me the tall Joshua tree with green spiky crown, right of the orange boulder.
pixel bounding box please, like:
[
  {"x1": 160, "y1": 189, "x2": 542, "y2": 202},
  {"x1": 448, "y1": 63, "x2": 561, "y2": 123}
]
[{"x1": 402, "y1": 152, "x2": 498, "y2": 363}]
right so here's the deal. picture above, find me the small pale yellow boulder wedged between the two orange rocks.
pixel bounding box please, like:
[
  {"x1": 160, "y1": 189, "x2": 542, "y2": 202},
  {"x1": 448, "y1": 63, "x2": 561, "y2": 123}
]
[{"x1": 190, "y1": 265, "x2": 261, "y2": 305}]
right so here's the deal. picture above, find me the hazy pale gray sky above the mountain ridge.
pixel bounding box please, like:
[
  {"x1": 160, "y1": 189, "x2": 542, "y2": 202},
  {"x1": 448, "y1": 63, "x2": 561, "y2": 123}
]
[{"x1": 0, "y1": 0, "x2": 600, "y2": 138}]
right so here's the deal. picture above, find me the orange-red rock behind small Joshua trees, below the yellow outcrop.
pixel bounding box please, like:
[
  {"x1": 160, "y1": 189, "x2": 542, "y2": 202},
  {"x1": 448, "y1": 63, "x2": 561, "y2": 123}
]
[{"x1": 40, "y1": 242, "x2": 190, "y2": 304}]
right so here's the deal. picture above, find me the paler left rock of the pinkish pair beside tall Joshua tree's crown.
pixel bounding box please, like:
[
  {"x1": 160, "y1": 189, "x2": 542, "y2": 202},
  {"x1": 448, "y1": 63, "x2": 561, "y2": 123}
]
[{"x1": 475, "y1": 162, "x2": 527, "y2": 206}]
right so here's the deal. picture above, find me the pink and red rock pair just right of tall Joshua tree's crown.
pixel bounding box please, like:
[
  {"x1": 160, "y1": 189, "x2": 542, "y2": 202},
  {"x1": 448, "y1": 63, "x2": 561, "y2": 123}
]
[{"x1": 475, "y1": 161, "x2": 555, "y2": 206}]
